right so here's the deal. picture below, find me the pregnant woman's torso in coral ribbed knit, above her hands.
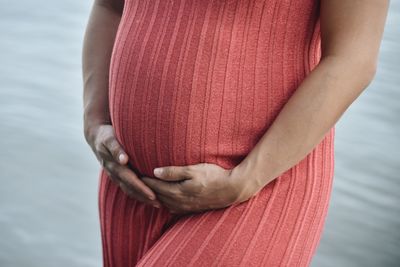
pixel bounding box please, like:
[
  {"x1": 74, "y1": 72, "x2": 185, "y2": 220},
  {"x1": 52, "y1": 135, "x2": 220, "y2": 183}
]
[{"x1": 109, "y1": 0, "x2": 320, "y2": 176}]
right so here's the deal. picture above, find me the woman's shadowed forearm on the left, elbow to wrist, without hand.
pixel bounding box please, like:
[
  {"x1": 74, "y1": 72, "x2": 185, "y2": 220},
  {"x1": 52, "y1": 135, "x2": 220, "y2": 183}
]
[{"x1": 82, "y1": 1, "x2": 121, "y2": 136}]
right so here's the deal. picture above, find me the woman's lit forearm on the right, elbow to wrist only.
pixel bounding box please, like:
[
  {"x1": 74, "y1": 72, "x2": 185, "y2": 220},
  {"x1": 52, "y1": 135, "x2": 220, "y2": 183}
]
[{"x1": 233, "y1": 56, "x2": 375, "y2": 203}]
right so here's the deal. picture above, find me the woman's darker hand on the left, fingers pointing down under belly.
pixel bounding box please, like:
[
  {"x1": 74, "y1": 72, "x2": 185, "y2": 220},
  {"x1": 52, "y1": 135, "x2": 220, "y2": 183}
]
[{"x1": 85, "y1": 124, "x2": 161, "y2": 208}]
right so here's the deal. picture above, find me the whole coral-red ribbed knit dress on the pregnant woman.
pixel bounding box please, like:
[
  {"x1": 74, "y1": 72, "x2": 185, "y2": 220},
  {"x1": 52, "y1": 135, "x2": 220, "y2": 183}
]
[{"x1": 99, "y1": 0, "x2": 334, "y2": 267}]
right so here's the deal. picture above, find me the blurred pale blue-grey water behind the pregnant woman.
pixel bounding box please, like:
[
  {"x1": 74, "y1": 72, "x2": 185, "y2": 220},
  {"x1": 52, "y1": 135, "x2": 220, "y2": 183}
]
[{"x1": 0, "y1": 0, "x2": 400, "y2": 267}]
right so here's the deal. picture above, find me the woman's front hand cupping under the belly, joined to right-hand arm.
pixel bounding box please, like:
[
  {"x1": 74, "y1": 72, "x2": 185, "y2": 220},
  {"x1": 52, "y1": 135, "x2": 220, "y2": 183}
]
[{"x1": 142, "y1": 163, "x2": 247, "y2": 214}]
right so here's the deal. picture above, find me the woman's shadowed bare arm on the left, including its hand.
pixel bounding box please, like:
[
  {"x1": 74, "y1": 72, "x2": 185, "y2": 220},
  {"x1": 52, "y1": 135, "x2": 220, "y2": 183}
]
[{"x1": 82, "y1": 0, "x2": 160, "y2": 209}]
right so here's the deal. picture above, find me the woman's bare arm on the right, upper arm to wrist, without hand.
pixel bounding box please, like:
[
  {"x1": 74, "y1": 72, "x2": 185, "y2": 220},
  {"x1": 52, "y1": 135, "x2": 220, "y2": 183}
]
[{"x1": 232, "y1": 0, "x2": 389, "y2": 202}]
